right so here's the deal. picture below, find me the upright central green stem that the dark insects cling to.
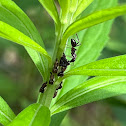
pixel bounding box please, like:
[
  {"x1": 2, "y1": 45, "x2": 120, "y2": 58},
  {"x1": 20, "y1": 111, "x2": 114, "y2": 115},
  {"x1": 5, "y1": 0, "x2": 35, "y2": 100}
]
[{"x1": 37, "y1": 17, "x2": 69, "y2": 107}]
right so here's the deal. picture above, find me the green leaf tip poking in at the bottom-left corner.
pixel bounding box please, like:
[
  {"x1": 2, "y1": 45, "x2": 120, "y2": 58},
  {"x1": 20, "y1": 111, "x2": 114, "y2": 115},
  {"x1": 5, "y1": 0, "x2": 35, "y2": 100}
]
[{"x1": 0, "y1": 96, "x2": 15, "y2": 125}]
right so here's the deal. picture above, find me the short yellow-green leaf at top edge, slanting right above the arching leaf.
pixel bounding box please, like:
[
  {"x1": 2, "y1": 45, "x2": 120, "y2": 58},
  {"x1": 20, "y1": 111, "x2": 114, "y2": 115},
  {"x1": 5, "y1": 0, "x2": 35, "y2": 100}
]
[{"x1": 73, "y1": 0, "x2": 94, "y2": 20}]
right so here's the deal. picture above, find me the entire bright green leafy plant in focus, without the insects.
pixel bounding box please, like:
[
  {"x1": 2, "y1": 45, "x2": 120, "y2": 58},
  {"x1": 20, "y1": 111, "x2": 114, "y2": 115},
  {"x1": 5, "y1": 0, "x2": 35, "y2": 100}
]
[{"x1": 0, "y1": 0, "x2": 126, "y2": 126}]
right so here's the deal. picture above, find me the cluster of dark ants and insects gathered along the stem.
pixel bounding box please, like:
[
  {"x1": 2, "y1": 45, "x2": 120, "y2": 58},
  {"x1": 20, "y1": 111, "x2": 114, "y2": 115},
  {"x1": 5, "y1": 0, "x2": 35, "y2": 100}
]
[{"x1": 39, "y1": 34, "x2": 79, "y2": 98}]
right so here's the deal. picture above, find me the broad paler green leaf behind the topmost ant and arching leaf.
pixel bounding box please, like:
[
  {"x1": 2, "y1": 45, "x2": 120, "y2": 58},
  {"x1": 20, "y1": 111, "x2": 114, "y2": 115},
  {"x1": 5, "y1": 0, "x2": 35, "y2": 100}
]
[{"x1": 72, "y1": 0, "x2": 117, "y2": 68}]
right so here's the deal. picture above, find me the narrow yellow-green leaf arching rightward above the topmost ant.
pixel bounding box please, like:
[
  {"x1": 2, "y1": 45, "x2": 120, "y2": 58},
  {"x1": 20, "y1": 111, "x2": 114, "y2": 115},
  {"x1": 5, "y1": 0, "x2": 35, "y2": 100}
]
[{"x1": 60, "y1": 5, "x2": 126, "y2": 50}]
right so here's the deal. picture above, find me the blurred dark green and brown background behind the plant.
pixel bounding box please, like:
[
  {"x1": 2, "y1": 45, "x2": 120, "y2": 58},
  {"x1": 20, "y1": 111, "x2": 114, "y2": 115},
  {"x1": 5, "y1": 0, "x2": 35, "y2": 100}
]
[{"x1": 0, "y1": 0, "x2": 126, "y2": 126}]
